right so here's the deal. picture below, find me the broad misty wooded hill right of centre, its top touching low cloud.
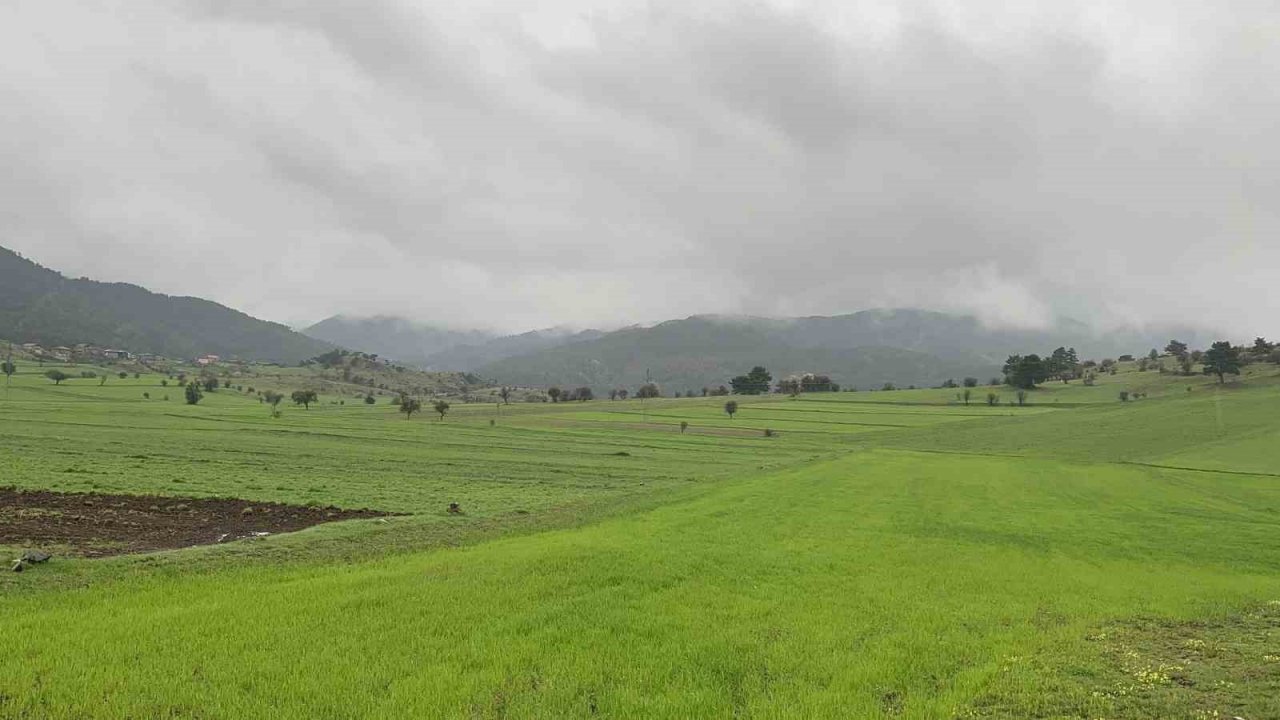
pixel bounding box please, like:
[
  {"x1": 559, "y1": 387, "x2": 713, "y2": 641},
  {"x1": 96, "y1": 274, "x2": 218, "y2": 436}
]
[{"x1": 475, "y1": 309, "x2": 1206, "y2": 392}]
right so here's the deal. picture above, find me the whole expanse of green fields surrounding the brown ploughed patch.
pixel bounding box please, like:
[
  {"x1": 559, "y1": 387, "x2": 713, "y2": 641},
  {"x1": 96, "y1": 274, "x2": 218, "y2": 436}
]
[{"x1": 0, "y1": 366, "x2": 1280, "y2": 720}]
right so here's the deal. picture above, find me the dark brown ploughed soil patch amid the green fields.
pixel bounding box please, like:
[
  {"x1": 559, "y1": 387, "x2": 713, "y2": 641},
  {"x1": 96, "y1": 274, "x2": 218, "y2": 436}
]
[{"x1": 0, "y1": 488, "x2": 393, "y2": 557}]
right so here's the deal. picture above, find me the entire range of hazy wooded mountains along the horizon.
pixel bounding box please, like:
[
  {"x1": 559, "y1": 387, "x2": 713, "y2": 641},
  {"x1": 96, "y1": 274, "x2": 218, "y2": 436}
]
[{"x1": 0, "y1": 240, "x2": 1213, "y2": 392}]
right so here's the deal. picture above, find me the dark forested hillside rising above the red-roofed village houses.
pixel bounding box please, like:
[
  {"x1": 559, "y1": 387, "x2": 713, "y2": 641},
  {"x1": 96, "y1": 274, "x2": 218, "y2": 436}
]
[{"x1": 0, "y1": 247, "x2": 332, "y2": 363}]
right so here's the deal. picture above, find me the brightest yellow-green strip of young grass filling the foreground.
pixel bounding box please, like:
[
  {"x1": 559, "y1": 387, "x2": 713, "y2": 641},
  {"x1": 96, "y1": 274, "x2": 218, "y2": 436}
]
[{"x1": 0, "y1": 451, "x2": 1280, "y2": 717}]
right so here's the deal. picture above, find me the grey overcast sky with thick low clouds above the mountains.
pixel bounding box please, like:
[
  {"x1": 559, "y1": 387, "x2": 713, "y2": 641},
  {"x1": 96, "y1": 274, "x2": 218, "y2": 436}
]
[{"x1": 0, "y1": 0, "x2": 1280, "y2": 337}]
